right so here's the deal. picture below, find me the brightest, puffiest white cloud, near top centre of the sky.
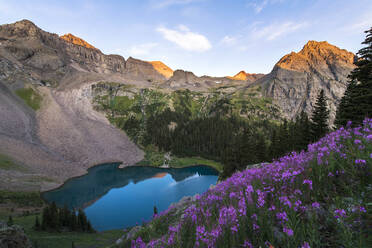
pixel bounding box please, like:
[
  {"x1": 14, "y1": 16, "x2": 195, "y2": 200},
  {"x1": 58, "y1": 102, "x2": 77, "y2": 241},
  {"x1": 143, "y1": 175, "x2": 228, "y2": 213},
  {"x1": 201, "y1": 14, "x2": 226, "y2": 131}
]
[{"x1": 156, "y1": 25, "x2": 212, "y2": 52}]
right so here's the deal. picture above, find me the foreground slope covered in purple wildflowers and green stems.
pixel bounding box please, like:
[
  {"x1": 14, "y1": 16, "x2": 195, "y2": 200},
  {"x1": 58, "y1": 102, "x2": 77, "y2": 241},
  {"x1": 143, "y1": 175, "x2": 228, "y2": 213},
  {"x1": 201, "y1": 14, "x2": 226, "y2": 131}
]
[{"x1": 120, "y1": 119, "x2": 372, "y2": 248}]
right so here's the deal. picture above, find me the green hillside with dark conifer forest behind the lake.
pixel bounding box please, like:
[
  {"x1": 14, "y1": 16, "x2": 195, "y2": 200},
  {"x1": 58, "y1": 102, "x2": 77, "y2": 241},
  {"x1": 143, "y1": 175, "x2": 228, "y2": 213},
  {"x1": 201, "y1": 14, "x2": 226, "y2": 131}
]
[{"x1": 96, "y1": 85, "x2": 308, "y2": 176}]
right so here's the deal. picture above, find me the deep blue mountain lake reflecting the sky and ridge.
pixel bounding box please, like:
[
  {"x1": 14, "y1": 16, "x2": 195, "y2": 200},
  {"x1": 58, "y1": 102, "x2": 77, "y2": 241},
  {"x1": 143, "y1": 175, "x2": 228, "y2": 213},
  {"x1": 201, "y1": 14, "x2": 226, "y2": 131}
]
[{"x1": 43, "y1": 164, "x2": 218, "y2": 231}]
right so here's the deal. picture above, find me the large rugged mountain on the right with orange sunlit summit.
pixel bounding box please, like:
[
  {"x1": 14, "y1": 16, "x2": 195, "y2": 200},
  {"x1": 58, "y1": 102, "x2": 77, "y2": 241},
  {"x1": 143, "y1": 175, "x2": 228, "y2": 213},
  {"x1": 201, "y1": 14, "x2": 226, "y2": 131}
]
[{"x1": 246, "y1": 41, "x2": 355, "y2": 123}]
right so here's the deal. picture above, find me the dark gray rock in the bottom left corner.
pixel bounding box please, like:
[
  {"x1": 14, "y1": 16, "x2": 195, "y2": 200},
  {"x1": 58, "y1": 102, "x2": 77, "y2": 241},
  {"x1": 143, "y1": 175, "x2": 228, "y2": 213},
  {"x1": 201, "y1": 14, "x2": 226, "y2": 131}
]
[{"x1": 0, "y1": 223, "x2": 32, "y2": 248}]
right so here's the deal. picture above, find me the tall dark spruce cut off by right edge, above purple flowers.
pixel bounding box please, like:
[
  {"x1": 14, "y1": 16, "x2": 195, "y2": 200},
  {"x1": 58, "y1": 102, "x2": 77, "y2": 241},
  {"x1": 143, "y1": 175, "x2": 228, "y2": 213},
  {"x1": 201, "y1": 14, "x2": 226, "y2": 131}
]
[{"x1": 335, "y1": 27, "x2": 372, "y2": 126}]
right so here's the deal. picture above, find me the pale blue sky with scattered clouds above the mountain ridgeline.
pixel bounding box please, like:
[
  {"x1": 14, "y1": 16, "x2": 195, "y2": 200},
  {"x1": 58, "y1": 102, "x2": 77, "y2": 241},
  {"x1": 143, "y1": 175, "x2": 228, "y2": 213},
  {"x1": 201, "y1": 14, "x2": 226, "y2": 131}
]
[{"x1": 0, "y1": 0, "x2": 372, "y2": 76}]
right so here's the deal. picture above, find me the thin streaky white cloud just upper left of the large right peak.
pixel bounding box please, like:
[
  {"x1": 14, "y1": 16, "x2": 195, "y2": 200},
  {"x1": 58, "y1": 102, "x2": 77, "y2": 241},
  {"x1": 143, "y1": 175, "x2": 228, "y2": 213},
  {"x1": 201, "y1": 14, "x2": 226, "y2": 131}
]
[{"x1": 252, "y1": 22, "x2": 308, "y2": 40}]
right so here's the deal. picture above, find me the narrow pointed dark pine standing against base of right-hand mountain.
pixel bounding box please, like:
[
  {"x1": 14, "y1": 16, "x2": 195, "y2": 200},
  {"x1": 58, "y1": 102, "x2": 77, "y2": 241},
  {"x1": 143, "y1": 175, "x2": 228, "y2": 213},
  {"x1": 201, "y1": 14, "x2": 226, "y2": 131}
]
[{"x1": 311, "y1": 90, "x2": 329, "y2": 141}]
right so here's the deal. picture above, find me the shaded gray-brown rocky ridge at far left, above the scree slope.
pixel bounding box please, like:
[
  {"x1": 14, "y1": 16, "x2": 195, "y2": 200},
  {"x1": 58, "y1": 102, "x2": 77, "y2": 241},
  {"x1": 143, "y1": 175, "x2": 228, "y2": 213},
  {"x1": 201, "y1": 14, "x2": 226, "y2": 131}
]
[{"x1": 0, "y1": 20, "x2": 125, "y2": 78}]
